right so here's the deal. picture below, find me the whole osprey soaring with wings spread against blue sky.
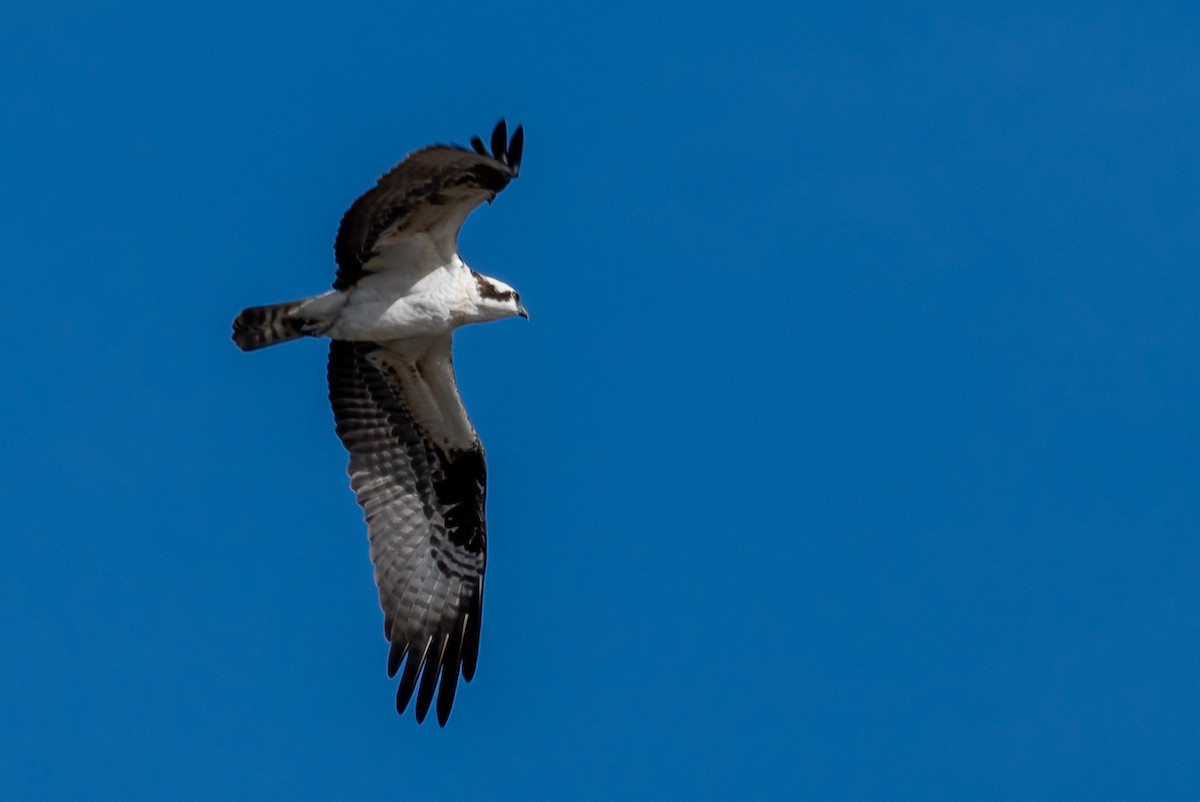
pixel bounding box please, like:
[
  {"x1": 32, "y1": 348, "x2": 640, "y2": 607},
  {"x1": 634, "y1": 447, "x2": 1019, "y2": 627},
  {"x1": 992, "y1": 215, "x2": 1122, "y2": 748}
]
[{"x1": 233, "y1": 120, "x2": 529, "y2": 726}]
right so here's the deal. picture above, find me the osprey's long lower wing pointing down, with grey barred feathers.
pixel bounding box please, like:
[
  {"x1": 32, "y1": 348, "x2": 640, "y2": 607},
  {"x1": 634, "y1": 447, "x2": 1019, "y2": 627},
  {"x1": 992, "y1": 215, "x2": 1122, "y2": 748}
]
[{"x1": 329, "y1": 339, "x2": 487, "y2": 725}]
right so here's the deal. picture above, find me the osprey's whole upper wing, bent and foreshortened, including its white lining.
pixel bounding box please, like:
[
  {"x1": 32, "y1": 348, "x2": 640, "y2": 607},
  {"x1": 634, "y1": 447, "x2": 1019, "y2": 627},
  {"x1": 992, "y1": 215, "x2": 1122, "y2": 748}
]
[{"x1": 334, "y1": 120, "x2": 524, "y2": 291}]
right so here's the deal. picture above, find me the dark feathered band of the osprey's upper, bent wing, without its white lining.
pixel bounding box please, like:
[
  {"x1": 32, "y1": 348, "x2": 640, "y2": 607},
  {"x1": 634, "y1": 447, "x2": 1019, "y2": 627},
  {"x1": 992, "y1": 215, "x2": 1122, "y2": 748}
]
[{"x1": 334, "y1": 120, "x2": 524, "y2": 291}]
